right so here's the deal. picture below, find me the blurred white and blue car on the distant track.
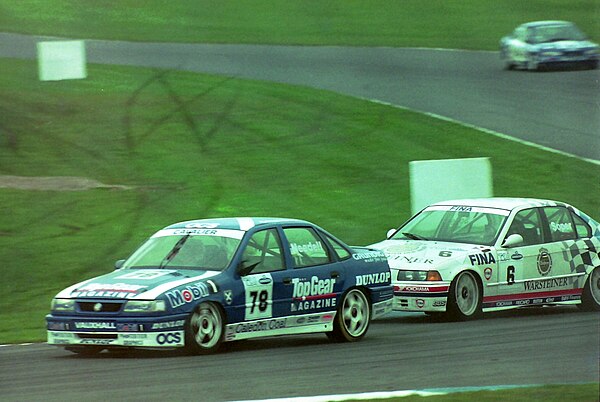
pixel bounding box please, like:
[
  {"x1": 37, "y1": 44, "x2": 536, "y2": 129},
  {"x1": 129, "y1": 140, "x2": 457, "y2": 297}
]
[{"x1": 500, "y1": 21, "x2": 600, "y2": 70}]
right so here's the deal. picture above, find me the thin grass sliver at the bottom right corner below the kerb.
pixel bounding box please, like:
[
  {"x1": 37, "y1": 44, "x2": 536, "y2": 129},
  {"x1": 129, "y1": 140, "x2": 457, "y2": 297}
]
[{"x1": 350, "y1": 383, "x2": 600, "y2": 402}]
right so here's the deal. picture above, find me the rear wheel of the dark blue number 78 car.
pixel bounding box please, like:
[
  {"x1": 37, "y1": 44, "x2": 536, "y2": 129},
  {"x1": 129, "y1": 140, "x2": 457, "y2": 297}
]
[{"x1": 327, "y1": 289, "x2": 371, "y2": 342}]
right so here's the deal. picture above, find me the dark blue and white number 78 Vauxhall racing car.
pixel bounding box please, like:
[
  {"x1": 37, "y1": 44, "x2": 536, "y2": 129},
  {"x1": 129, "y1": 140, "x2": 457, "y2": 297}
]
[{"x1": 46, "y1": 218, "x2": 393, "y2": 354}]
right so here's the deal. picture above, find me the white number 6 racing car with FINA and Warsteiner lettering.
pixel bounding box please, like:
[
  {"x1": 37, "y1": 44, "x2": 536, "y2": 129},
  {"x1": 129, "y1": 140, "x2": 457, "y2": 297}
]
[{"x1": 371, "y1": 197, "x2": 600, "y2": 320}]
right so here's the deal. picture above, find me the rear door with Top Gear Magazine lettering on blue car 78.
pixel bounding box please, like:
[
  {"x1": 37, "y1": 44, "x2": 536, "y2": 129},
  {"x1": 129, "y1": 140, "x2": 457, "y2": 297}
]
[{"x1": 283, "y1": 227, "x2": 345, "y2": 315}]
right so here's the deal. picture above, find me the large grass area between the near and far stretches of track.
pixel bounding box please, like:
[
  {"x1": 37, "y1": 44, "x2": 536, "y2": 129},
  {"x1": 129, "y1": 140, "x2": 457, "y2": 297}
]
[{"x1": 0, "y1": 59, "x2": 600, "y2": 343}]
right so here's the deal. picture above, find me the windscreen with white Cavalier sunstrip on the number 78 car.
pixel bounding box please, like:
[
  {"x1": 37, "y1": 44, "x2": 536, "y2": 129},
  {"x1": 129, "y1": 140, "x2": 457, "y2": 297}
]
[{"x1": 123, "y1": 229, "x2": 244, "y2": 271}]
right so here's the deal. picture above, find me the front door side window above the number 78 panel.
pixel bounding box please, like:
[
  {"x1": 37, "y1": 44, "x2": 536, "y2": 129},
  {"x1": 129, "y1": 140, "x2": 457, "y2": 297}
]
[{"x1": 242, "y1": 229, "x2": 285, "y2": 274}]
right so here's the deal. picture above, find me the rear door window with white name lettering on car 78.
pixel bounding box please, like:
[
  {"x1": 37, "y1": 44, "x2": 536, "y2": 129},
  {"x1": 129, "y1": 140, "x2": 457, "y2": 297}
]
[{"x1": 283, "y1": 227, "x2": 332, "y2": 268}]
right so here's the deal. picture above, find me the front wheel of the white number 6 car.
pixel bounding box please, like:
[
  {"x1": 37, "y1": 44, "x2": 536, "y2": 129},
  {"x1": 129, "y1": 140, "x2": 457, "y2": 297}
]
[{"x1": 448, "y1": 271, "x2": 482, "y2": 321}]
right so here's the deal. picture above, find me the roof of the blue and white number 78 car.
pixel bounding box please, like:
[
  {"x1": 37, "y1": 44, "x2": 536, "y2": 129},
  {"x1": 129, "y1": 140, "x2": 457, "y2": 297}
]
[{"x1": 165, "y1": 217, "x2": 312, "y2": 231}]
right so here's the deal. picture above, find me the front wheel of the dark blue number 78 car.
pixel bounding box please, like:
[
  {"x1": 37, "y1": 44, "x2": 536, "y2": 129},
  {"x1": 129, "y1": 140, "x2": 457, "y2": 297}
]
[{"x1": 185, "y1": 302, "x2": 225, "y2": 354}]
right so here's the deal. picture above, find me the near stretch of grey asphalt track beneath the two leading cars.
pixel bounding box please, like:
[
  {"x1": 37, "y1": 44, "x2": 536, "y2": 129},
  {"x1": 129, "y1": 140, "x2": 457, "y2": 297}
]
[{"x1": 0, "y1": 307, "x2": 600, "y2": 401}]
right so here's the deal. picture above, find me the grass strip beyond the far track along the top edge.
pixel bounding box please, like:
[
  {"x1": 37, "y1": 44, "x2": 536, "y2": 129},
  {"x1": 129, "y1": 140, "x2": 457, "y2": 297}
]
[{"x1": 0, "y1": 0, "x2": 600, "y2": 50}]
